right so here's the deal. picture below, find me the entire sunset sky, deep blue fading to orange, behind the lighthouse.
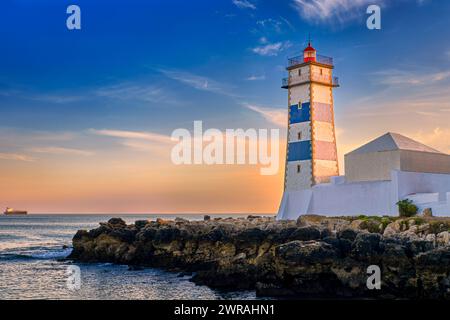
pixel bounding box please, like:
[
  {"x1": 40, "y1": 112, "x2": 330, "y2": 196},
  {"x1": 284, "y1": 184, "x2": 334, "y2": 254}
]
[{"x1": 0, "y1": 0, "x2": 450, "y2": 213}]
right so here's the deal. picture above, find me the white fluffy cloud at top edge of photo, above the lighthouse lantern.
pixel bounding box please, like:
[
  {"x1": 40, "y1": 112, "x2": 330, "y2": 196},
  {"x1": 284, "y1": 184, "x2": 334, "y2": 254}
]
[{"x1": 293, "y1": 0, "x2": 378, "y2": 23}]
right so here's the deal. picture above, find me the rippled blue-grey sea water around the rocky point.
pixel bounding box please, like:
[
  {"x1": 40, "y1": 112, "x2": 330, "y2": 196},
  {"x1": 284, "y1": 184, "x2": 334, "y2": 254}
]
[{"x1": 0, "y1": 214, "x2": 256, "y2": 299}]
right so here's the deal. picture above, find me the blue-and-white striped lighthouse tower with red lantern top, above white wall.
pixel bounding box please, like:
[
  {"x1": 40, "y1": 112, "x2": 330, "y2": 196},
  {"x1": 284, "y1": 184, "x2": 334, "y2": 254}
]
[{"x1": 280, "y1": 42, "x2": 339, "y2": 218}]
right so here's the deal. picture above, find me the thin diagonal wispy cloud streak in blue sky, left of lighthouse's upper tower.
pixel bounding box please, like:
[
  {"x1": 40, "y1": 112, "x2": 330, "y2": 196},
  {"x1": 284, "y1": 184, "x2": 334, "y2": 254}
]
[{"x1": 159, "y1": 69, "x2": 234, "y2": 96}]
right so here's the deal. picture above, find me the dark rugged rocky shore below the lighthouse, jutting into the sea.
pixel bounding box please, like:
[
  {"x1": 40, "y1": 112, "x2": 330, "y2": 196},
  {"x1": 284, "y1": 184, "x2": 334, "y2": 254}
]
[{"x1": 68, "y1": 216, "x2": 450, "y2": 299}]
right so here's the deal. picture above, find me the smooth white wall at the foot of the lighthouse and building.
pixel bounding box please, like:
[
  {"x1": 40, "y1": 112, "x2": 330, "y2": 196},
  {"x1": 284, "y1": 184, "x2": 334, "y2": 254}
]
[{"x1": 277, "y1": 170, "x2": 450, "y2": 220}]
